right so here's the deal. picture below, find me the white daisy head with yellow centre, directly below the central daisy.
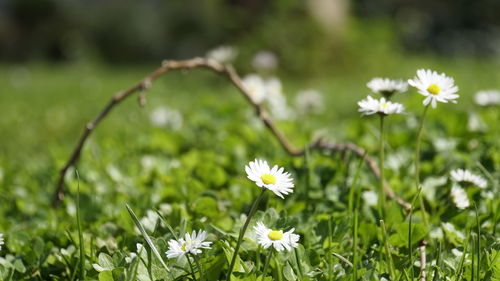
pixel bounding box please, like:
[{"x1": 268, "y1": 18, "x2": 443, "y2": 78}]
[{"x1": 254, "y1": 222, "x2": 300, "y2": 252}]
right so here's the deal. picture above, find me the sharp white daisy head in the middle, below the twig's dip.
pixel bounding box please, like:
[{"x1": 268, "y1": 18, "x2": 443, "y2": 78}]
[{"x1": 245, "y1": 159, "x2": 294, "y2": 199}]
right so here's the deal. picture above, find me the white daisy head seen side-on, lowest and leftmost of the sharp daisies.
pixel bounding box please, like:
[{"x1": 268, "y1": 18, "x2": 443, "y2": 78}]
[{"x1": 166, "y1": 230, "x2": 212, "y2": 258}]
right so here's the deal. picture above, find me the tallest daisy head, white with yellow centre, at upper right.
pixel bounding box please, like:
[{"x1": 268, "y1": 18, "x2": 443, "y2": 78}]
[{"x1": 408, "y1": 69, "x2": 459, "y2": 108}]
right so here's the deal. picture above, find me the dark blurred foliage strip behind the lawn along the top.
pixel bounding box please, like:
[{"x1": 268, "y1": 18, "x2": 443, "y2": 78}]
[{"x1": 0, "y1": 0, "x2": 500, "y2": 72}]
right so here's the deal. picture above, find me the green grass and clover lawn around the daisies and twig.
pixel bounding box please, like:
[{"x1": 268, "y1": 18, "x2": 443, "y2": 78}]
[{"x1": 0, "y1": 54, "x2": 500, "y2": 280}]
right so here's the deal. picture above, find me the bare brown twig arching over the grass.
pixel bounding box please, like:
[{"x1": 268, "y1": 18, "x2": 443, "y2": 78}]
[{"x1": 52, "y1": 57, "x2": 410, "y2": 210}]
